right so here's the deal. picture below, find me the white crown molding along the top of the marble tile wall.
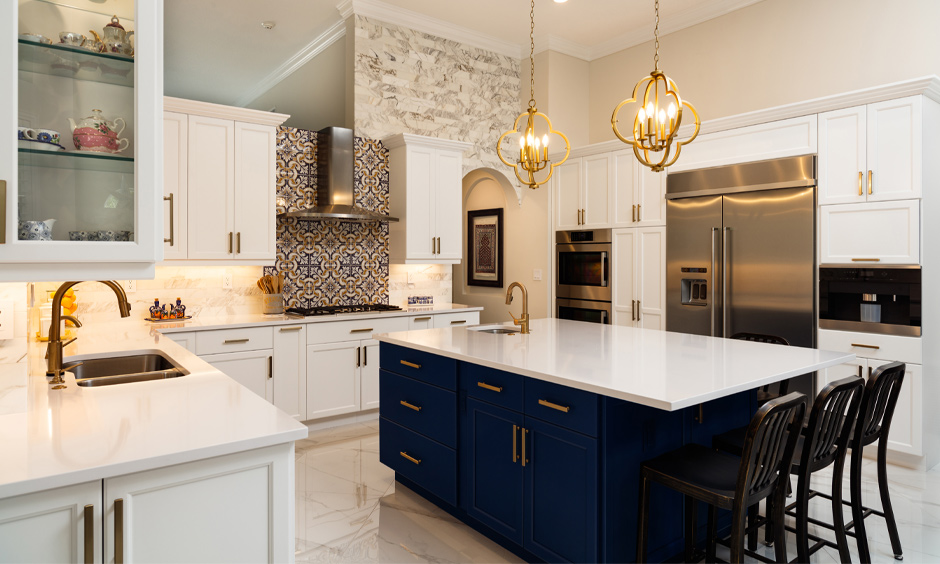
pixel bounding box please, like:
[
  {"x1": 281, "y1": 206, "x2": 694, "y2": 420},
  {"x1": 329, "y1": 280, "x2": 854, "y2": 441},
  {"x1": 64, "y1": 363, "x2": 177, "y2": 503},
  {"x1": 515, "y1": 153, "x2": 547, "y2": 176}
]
[{"x1": 336, "y1": 0, "x2": 523, "y2": 59}]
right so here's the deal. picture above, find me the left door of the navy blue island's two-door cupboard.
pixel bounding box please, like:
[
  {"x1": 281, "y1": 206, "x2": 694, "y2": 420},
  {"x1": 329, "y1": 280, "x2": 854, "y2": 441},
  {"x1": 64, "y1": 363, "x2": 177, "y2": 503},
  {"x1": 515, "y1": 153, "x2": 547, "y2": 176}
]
[{"x1": 460, "y1": 398, "x2": 531, "y2": 546}]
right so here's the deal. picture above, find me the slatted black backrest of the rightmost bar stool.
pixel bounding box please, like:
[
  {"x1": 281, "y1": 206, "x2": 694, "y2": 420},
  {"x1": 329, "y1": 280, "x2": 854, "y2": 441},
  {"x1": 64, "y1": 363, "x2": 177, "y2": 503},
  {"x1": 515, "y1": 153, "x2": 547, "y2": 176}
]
[{"x1": 852, "y1": 362, "x2": 907, "y2": 448}]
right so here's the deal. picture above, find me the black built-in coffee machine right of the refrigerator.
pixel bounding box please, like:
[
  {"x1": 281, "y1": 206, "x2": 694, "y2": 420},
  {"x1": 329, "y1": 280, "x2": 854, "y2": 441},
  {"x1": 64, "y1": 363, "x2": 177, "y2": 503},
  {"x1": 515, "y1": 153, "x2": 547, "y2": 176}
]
[{"x1": 819, "y1": 265, "x2": 921, "y2": 336}]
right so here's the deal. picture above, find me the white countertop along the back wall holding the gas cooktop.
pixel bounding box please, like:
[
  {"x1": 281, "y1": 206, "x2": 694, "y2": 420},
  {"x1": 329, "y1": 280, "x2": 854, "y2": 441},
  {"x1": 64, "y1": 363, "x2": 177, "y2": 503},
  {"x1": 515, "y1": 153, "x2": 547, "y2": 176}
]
[{"x1": 152, "y1": 304, "x2": 483, "y2": 333}]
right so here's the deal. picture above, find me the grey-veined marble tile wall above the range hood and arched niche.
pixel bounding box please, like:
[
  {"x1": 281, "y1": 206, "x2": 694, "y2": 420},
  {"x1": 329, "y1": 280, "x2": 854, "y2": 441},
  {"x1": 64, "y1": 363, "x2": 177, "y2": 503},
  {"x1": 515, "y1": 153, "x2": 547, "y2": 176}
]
[{"x1": 354, "y1": 15, "x2": 522, "y2": 174}]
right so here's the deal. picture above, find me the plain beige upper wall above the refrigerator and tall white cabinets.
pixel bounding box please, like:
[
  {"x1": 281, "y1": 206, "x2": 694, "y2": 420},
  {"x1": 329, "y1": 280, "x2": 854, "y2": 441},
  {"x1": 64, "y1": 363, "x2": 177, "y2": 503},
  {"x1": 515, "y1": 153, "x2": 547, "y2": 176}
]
[{"x1": 590, "y1": 0, "x2": 940, "y2": 143}]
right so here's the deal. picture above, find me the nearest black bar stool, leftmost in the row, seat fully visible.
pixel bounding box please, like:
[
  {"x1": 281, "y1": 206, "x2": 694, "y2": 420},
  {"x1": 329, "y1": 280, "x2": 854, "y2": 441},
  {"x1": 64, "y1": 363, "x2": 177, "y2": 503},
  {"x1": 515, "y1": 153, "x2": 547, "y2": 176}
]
[{"x1": 637, "y1": 393, "x2": 806, "y2": 562}]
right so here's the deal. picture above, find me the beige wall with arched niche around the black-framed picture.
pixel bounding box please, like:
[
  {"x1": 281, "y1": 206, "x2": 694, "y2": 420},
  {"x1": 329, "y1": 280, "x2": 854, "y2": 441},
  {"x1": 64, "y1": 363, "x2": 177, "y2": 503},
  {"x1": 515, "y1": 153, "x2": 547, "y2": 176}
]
[{"x1": 454, "y1": 170, "x2": 552, "y2": 323}]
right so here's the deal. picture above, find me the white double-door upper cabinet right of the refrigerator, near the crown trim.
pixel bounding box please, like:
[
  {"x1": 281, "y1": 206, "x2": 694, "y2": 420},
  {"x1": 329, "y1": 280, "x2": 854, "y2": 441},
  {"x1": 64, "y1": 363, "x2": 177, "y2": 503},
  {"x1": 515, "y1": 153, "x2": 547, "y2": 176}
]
[{"x1": 818, "y1": 96, "x2": 923, "y2": 205}]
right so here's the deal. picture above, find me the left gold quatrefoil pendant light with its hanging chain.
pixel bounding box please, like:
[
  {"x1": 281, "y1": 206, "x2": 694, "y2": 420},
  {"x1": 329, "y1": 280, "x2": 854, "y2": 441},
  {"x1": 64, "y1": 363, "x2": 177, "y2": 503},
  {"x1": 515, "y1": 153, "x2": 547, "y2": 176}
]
[{"x1": 496, "y1": 0, "x2": 571, "y2": 190}]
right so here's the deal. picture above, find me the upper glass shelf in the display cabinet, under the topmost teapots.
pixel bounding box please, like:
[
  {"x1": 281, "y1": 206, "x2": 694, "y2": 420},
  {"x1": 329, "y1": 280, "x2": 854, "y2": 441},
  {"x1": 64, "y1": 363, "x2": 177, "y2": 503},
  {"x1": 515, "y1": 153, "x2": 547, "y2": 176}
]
[{"x1": 19, "y1": 39, "x2": 134, "y2": 88}]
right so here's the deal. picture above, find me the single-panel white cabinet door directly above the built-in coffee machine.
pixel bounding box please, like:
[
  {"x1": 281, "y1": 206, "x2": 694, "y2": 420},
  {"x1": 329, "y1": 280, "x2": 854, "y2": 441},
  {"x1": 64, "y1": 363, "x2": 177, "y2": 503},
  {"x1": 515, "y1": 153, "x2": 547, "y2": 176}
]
[{"x1": 819, "y1": 200, "x2": 920, "y2": 264}]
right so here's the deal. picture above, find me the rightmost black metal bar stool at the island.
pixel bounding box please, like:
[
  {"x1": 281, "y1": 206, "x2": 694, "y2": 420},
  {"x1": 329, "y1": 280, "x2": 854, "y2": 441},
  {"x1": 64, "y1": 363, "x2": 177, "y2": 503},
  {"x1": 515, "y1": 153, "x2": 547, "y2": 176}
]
[{"x1": 788, "y1": 362, "x2": 906, "y2": 564}]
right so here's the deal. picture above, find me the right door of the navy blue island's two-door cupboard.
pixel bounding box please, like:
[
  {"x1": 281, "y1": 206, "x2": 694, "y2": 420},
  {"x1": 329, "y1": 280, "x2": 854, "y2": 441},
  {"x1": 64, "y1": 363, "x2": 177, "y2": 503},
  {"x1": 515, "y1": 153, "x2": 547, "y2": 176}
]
[{"x1": 521, "y1": 417, "x2": 599, "y2": 562}]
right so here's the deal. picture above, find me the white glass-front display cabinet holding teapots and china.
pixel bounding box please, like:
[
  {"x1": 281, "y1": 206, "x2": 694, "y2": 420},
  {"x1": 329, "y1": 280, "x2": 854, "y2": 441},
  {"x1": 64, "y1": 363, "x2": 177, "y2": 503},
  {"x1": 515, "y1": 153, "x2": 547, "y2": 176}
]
[{"x1": 0, "y1": 0, "x2": 164, "y2": 280}]
